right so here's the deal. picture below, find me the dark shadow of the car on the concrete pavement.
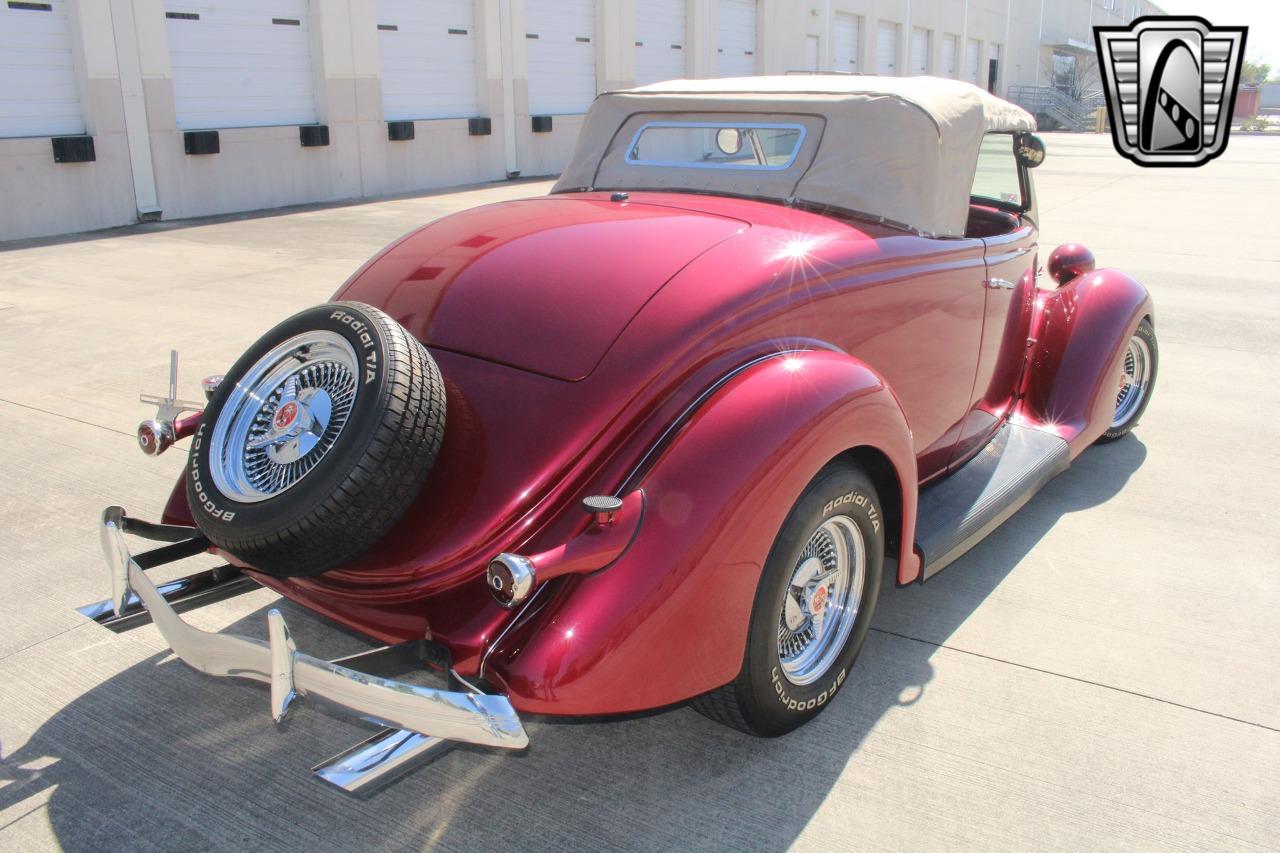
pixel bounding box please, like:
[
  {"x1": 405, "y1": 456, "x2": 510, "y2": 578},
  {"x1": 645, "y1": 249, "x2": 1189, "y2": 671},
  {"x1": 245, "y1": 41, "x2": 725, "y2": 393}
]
[{"x1": 0, "y1": 437, "x2": 1146, "y2": 850}]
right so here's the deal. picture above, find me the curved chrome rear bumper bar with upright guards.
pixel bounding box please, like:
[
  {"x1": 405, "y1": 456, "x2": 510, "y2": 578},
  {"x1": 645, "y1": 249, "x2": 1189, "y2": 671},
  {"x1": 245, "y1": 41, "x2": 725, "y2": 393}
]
[{"x1": 92, "y1": 507, "x2": 529, "y2": 749}]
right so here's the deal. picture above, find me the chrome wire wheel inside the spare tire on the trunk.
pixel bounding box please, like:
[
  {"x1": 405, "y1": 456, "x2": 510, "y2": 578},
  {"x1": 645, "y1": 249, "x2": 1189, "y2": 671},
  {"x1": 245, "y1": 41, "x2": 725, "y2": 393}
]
[{"x1": 209, "y1": 330, "x2": 360, "y2": 503}]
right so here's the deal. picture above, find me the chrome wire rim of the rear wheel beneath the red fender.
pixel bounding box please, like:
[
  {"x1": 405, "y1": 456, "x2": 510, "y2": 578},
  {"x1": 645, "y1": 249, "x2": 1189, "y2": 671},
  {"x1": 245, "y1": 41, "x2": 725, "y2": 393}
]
[{"x1": 778, "y1": 515, "x2": 867, "y2": 686}]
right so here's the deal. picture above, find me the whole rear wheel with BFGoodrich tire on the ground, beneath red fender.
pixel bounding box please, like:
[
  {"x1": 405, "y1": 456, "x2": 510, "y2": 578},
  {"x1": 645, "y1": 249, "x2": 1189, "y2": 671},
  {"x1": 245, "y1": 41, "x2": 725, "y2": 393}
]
[{"x1": 691, "y1": 462, "x2": 884, "y2": 738}]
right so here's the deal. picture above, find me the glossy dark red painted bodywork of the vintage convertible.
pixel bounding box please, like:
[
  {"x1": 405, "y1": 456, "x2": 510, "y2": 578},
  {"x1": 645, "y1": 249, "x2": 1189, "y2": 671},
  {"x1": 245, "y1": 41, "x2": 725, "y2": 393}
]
[{"x1": 157, "y1": 192, "x2": 1151, "y2": 715}]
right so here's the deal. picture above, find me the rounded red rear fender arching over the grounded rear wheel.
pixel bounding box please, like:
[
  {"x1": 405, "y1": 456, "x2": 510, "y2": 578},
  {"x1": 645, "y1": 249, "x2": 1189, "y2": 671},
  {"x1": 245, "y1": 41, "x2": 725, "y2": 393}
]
[{"x1": 484, "y1": 351, "x2": 919, "y2": 715}]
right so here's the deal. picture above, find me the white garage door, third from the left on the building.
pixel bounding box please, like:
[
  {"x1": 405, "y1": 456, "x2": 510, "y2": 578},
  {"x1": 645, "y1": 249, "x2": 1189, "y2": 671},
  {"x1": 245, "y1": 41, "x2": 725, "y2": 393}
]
[{"x1": 378, "y1": 0, "x2": 480, "y2": 120}]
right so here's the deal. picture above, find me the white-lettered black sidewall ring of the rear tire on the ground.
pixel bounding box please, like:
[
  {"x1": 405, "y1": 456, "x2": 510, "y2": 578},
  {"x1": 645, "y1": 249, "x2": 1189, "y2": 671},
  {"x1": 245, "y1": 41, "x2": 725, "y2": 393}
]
[{"x1": 744, "y1": 464, "x2": 884, "y2": 735}]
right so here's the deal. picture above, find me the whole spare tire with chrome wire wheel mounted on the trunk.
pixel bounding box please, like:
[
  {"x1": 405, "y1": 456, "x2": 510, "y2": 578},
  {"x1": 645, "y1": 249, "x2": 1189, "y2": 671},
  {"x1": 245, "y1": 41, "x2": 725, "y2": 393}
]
[{"x1": 186, "y1": 302, "x2": 444, "y2": 578}]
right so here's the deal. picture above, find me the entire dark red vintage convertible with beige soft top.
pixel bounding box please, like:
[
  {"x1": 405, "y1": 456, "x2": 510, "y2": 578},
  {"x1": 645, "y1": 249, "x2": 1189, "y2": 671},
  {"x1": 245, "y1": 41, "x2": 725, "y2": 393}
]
[{"x1": 83, "y1": 76, "x2": 1157, "y2": 790}]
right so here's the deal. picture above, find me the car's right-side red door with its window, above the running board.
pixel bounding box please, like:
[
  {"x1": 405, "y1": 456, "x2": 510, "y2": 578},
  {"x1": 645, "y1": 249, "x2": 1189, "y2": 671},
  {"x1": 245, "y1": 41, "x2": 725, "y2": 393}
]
[{"x1": 951, "y1": 133, "x2": 1038, "y2": 467}]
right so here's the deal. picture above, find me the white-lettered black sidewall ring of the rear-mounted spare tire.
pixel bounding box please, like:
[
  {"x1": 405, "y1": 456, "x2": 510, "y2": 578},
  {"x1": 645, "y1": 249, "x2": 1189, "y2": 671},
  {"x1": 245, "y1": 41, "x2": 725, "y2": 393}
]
[{"x1": 184, "y1": 302, "x2": 390, "y2": 538}]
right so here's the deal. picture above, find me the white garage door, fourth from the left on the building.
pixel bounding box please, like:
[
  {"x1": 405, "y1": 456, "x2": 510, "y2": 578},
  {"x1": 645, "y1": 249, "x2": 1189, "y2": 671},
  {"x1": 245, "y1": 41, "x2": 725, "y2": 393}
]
[{"x1": 525, "y1": 0, "x2": 595, "y2": 115}]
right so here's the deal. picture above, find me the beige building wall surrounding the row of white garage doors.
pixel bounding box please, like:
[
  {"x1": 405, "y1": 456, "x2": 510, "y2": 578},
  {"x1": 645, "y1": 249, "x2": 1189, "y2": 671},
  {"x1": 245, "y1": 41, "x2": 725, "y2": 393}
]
[{"x1": 0, "y1": 0, "x2": 1153, "y2": 241}]
